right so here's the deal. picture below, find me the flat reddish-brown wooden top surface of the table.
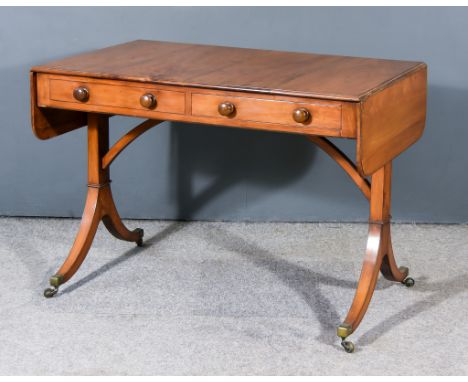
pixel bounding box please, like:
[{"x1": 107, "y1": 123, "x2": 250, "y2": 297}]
[{"x1": 32, "y1": 40, "x2": 425, "y2": 102}]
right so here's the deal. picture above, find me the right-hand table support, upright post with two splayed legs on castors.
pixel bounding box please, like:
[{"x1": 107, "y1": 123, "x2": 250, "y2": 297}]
[{"x1": 337, "y1": 163, "x2": 414, "y2": 353}]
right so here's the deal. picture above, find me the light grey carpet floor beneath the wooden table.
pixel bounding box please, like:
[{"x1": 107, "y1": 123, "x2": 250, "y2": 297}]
[{"x1": 0, "y1": 218, "x2": 468, "y2": 375}]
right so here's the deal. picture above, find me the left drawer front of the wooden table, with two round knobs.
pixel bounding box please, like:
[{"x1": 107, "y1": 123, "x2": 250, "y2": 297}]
[{"x1": 39, "y1": 77, "x2": 185, "y2": 114}]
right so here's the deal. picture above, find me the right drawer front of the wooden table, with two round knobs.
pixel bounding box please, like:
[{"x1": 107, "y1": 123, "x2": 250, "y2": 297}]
[{"x1": 192, "y1": 93, "x2": 342, "y2": 132}]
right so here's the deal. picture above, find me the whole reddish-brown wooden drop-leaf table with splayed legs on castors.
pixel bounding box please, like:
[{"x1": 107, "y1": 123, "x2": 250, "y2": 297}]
[{"x1": 30, "y1": 41, "x2": 427, "y2": 352}]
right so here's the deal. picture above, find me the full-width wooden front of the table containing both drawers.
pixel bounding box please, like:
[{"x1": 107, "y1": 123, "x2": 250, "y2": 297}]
[{"x1": 36, "y1": 73, "x2": 359, "y2": 138}]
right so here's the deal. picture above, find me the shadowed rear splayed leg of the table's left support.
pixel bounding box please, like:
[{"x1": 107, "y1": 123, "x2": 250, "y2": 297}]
[{"x1": 102, "y1": 186, "x2": 144, "y2": 247}]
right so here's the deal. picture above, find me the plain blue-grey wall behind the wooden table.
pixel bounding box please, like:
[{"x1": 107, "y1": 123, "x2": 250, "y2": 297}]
[{"x1": 0, "y1": 7, "x2": 468, "y2": 222}]
